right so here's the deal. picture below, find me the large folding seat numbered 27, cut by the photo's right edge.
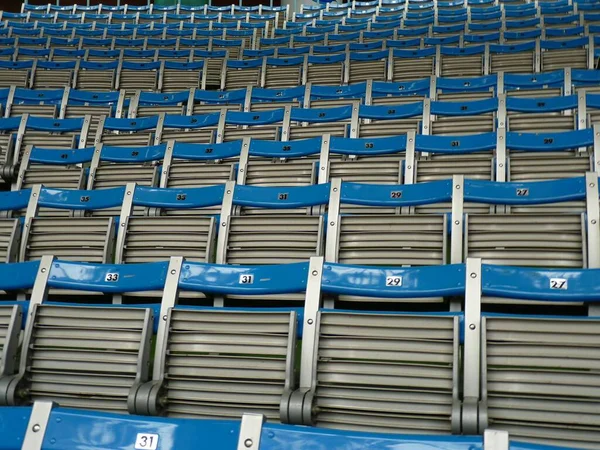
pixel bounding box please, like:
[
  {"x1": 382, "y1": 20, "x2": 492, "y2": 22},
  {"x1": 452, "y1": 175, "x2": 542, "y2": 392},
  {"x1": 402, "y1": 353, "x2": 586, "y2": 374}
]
[{"x1": 474, "y1": 264, "x2": 600, "y2": 449}]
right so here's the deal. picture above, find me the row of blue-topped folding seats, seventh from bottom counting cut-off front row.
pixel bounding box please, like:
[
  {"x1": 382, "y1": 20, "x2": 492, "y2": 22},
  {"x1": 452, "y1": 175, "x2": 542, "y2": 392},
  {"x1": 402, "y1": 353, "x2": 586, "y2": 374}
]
[{"x1": 0, "y1": 38, "x2": 596, "y2": 92}]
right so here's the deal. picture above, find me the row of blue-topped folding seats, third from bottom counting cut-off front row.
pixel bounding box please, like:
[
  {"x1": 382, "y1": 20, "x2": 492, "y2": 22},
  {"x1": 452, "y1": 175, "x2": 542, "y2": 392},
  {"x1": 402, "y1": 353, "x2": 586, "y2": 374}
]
[{"x1": 0, "y1": 175, "x2": 600, "y2": 282}]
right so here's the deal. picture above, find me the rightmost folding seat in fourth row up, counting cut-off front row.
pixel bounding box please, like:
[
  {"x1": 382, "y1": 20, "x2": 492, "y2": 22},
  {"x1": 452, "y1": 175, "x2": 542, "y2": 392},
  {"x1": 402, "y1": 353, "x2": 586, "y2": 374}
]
[{"x1": 506, "y1": 129, "x2": 598, "y2": 182}]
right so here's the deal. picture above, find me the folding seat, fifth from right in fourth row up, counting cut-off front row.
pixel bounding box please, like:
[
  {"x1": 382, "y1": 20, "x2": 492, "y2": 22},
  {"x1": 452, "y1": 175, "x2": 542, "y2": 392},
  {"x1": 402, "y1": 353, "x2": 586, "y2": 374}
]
[{"x1": 160, "y1": 141, "x2": 242, "y2": 188}]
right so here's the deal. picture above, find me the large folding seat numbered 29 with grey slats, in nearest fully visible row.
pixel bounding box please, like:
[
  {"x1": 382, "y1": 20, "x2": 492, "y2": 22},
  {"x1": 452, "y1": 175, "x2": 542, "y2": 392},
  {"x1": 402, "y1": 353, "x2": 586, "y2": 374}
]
[{"x1": 290, "y1": 258, "x2": 468, "y2": 435}]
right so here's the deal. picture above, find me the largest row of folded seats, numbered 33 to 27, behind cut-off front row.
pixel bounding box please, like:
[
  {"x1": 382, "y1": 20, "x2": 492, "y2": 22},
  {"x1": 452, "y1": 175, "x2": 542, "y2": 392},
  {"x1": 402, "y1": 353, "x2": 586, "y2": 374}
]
[{"x1": 0, "y1": 256, "x2": 600, "y2": 449}]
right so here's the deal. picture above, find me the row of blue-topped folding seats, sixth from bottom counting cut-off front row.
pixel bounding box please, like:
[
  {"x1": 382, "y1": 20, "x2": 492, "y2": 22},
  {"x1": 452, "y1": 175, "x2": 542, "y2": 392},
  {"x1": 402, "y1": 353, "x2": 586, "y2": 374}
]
[{"x1": 0, "y1": 68, "x2": 600, "y2": 114}]
